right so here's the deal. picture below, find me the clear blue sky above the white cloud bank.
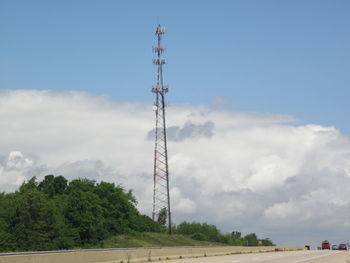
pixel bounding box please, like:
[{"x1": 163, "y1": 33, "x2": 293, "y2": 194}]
[{"x1": 0, "y1": 0, "x2": 350, "y2": 135}]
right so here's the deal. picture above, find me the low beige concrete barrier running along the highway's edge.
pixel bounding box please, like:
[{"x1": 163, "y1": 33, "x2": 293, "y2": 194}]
[{"x1": 0, "y1": 246, "x2": 305, "y2": 263}]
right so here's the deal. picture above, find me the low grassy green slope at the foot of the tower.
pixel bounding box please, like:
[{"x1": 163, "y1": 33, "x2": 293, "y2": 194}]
[{"x1": 94, "y1": 233, "x2": 226, "y2": 248}]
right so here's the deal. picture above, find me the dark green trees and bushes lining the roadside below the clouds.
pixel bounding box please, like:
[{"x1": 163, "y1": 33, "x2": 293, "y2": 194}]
[{"x1": 0, "y1": 175, "x2": 273, "y2": 252}]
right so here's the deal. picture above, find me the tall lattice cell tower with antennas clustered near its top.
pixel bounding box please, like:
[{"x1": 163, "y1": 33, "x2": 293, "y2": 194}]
[{"x1": 152, "y1": 25, "x2": 172, "y2": 234}]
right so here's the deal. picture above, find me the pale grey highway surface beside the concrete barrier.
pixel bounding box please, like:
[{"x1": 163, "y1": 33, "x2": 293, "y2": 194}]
[{"x1": 162, "y1": 250, "x2": 350, "y2": 263}]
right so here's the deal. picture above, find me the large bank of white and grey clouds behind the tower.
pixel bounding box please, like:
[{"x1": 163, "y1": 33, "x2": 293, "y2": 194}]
[{"x1": 0, "y1": 90, "x2": 350, "y2": 248}]
